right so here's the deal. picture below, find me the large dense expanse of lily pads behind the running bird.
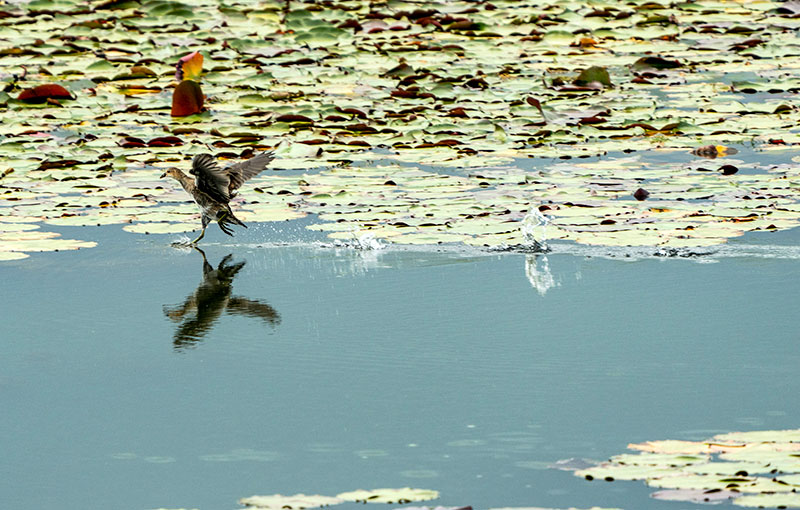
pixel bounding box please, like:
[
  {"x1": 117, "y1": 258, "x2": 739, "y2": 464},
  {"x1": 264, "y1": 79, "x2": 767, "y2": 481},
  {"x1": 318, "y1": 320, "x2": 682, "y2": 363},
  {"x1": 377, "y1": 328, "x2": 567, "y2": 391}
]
[{"x1": 0, "y1": 0, "x2": 800, "y2": 257}]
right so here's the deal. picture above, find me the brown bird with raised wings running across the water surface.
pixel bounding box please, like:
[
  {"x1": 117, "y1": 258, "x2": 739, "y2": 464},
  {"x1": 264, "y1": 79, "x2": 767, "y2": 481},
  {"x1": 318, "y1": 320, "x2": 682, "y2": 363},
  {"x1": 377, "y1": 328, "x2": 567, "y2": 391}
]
[{"x1": 161, "y1": 152, "x2": 275, "y2": 246}]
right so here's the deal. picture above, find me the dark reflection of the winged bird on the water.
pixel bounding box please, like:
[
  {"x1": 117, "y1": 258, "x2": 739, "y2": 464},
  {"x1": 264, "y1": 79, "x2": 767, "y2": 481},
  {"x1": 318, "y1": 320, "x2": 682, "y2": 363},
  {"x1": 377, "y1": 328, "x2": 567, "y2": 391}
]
[{"x1": 164, "y1": 246, "x2": 281, "y2": 350}]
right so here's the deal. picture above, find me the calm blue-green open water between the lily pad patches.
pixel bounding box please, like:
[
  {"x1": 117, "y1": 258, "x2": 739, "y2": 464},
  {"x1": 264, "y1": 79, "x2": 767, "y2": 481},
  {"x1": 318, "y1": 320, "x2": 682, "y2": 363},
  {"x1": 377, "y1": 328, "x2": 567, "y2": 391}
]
[{"x1": 0, "y1": 226, "x2": 800, "y2": 510}]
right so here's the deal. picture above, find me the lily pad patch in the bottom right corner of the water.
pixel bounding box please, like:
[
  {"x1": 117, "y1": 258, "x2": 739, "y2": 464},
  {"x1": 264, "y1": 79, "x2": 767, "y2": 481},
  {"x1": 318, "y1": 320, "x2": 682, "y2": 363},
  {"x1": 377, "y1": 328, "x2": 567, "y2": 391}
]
[{"x1": 575, "y1": 429, "x2": 800, "y2": 508}]
